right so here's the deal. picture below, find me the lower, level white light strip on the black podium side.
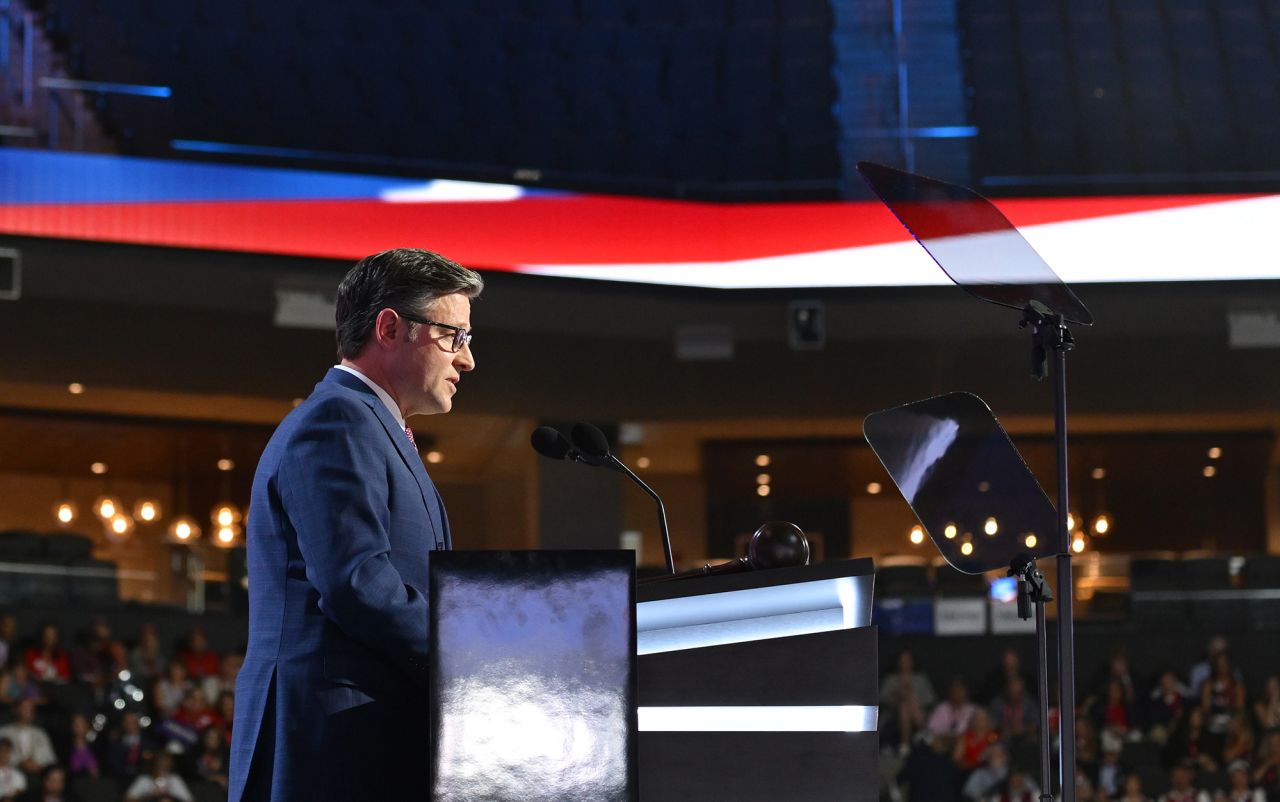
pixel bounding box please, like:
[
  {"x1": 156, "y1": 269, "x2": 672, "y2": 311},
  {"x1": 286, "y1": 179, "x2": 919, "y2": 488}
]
[{"x1": 636, "y1": 705, "x2": 879, "y2": 733}]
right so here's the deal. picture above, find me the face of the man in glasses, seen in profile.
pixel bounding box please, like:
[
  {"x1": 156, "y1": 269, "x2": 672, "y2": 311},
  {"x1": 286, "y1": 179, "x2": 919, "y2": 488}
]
[{"x1": 390, "y1": 293, "x2": 475, "y2": 417}]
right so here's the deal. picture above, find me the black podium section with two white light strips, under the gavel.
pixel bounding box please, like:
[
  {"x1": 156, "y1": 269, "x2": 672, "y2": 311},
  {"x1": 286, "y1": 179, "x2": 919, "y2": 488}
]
[{"x1": 636, "y1": 559, "x2": 879, "y2": 802}]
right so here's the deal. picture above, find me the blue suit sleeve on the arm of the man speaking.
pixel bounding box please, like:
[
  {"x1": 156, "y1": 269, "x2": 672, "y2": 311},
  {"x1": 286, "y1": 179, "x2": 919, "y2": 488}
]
[{"x1": 279, "y1": 399, "x2": 428, "y2": 678}]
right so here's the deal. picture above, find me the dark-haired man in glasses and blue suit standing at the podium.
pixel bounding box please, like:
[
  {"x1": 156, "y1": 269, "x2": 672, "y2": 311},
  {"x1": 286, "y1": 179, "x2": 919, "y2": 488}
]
[{"x1": 229, "y1": 249, "x2": 483, "y2": 802}]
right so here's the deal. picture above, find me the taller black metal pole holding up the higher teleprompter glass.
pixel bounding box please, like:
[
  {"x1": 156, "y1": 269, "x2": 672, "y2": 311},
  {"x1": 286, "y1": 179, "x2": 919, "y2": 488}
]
[{"x1": 1039, "y1": 326, "x2": 1075, "y2": 802}]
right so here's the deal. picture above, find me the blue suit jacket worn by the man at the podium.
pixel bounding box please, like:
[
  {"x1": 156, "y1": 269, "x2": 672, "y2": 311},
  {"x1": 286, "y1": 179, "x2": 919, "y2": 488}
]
[{"x1": 229, "y1": 368, "x2": 452, "y2": 802}]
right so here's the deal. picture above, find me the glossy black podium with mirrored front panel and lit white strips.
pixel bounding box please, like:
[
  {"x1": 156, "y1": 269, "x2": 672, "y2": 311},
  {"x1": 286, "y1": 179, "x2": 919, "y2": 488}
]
[{"x1": 428, "y1": 551, "x2": 878, "y2": 802}]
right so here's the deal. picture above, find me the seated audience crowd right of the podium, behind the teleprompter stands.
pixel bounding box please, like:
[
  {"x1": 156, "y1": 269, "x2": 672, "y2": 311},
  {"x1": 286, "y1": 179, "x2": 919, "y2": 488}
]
[{"x1": 879, "y1": 637, "x2": 1280, "y2": 802}]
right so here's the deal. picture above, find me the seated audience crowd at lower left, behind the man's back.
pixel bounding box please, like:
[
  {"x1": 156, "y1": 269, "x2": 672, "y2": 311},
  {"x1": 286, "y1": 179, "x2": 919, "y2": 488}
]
[{"x1": 0, "y1": 615, "x2": 243, "y2": 802}]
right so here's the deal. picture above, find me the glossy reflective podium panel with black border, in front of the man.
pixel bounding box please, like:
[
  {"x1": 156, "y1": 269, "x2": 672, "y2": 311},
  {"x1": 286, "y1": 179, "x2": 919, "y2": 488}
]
[{"x1": 430, "y1": 551, "x2": 639, "y2": 802}]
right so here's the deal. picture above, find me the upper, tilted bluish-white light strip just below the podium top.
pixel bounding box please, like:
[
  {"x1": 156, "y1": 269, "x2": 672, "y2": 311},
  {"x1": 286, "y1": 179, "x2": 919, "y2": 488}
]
[{"x1": 636, "y1": 576, "x2": 872, "y2": 655}]
